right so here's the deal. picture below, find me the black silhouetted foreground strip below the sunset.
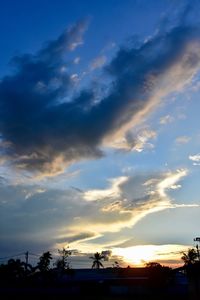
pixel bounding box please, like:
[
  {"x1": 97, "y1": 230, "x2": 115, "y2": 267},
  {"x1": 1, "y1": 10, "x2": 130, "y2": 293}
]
[{"x1": 0, "y1": 257, "x2": 200, "y2": 300}]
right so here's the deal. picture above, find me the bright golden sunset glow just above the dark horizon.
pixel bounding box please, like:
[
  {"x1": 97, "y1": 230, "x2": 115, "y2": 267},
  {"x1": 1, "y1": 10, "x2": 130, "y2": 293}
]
[{"x1": 112, "y1": 245, "x2": 189, "y2": 267}]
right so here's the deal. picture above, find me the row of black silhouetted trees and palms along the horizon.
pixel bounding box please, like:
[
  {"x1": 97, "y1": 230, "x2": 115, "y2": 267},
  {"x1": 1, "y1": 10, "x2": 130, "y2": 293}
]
[{"x1": 0, "y1": 248, "x2": 200, "y2": 286}]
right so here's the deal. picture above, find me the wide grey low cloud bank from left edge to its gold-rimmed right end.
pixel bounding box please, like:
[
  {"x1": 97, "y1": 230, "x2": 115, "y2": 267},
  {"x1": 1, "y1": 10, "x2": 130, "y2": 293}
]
[{"x1": 0, "y1": 170, "x2": 198, "y2": 254}]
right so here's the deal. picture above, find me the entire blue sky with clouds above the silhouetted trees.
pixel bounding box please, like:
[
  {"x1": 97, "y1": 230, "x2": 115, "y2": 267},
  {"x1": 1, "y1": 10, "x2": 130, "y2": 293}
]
[{"x1": 0, "y1": 0, "x2": 200, "y2": 268}]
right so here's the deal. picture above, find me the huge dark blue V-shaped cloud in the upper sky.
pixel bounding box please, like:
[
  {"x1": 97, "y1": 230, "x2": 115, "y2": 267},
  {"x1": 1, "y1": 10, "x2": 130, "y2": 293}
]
[{"x1": 0, "y1": 17, "x2": 200, "y2": 175}]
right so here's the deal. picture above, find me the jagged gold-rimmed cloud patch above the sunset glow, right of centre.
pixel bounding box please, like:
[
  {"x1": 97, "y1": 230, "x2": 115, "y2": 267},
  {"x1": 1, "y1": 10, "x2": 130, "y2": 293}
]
[{"x1": 72, "y1": 170, "x2": 191, "y2": 233}]
